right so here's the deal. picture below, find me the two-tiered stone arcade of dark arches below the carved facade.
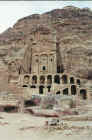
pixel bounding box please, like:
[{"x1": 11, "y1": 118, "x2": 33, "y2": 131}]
[{"x1": 21, "y1": 74, "x2": 87, "y2": 100}]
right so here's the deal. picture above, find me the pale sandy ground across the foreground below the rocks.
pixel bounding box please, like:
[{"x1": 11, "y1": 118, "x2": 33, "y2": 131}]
[{"x1": 0, "y1": 113, "x2": 92, "y2": 140}]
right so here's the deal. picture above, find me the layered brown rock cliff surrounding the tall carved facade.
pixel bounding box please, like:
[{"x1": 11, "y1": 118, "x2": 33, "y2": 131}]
[{"x1": 0, "y1": 6, "x2": 92, "y2": 90}]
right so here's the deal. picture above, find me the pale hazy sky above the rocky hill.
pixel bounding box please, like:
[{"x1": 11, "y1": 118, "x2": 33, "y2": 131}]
[{"x1": 0, "y1": 0, "x2": 92, "y2": 33}]
